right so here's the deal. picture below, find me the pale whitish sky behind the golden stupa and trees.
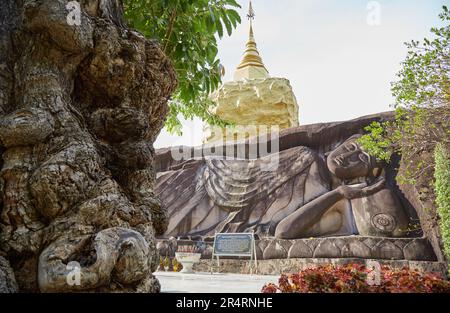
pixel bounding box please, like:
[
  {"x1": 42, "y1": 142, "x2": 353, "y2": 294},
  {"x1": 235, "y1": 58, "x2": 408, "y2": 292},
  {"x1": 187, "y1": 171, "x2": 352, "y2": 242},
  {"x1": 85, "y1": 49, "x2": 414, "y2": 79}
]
[{"x1": 155, "y1": 0, "x2": 450, "y2": 148}]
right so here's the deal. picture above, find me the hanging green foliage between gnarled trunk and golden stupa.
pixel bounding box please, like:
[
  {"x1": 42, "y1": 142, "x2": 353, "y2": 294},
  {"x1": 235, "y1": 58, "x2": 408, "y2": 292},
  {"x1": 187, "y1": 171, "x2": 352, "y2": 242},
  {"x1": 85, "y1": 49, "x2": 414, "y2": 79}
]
[{"x1": 124, "y1": 0, "x2": 241, "y2": 134}]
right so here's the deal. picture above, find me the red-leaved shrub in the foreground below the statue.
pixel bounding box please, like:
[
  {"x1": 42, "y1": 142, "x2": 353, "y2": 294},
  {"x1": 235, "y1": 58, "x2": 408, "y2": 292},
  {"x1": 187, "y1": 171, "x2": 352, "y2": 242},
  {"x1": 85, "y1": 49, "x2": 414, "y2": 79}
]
[{"x1": 262, "y1": 264, "x2": 450, "y2": 293}]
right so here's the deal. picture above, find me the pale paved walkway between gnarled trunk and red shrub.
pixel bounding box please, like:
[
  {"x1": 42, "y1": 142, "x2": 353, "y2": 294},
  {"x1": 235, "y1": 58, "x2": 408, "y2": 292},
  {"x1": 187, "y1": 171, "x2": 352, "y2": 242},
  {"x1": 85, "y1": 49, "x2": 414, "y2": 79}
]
[{"x1": 155, "y1": 272, "x2": 279, "y2": 293}]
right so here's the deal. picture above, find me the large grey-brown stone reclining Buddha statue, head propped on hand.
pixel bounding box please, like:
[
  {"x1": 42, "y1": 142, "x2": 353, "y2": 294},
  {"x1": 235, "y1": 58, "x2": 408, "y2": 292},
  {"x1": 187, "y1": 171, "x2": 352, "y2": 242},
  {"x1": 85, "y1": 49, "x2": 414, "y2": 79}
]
[{"x1": 156, "y1": 135, "x2": 410, "y2": 239}]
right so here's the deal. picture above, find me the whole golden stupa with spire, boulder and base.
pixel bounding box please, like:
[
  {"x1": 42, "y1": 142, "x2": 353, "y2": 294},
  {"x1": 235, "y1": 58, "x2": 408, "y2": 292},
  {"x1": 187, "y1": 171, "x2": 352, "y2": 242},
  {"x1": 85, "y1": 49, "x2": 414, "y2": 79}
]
[{"x1": 203, "y1": 1, "x2": 298, "y2": 143}]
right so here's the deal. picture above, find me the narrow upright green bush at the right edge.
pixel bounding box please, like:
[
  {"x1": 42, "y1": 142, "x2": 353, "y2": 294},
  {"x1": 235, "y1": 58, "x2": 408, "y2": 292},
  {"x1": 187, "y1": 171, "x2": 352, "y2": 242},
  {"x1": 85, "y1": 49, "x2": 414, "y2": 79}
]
[{"x1": 434, "y1": 144, "x2": 450, "y2": 260}]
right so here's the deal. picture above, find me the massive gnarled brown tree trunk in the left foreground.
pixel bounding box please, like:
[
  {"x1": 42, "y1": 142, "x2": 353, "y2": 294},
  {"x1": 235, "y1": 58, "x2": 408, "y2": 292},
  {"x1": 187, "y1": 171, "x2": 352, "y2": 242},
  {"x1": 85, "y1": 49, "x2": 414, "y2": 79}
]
[{"x1": 0, "y1": 0, "x2": 177, "y2": 292}]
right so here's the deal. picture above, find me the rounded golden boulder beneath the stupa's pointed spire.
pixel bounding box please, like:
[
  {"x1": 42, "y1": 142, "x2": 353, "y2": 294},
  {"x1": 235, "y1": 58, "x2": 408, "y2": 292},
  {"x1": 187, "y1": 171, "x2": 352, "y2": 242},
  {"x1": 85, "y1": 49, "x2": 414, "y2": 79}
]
[{"x1": 205, "y1": 78, "x2": 298, "y2": 142}]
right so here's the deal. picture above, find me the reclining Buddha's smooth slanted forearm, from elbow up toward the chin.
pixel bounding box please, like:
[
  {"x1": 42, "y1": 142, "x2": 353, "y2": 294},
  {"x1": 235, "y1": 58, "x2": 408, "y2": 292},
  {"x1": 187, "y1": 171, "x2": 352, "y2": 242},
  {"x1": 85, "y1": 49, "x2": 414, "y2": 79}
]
[{"x1": 275, "y1": 189, "x2": 344, "y2": 239}]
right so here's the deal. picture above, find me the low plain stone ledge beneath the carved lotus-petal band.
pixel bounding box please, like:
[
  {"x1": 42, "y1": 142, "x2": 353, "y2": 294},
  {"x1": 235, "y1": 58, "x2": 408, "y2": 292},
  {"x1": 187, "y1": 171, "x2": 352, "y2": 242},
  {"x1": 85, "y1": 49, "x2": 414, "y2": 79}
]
[{"x1": 194, "y1": 258, "x2": 447, "y2": 277}]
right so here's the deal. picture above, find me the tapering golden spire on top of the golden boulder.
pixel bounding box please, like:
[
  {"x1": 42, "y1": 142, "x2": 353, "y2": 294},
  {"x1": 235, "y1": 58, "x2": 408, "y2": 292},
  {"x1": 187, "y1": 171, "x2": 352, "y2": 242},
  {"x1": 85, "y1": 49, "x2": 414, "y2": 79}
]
[{"x1": 234, "y1": 0, "x2": 269, "y2": 80}]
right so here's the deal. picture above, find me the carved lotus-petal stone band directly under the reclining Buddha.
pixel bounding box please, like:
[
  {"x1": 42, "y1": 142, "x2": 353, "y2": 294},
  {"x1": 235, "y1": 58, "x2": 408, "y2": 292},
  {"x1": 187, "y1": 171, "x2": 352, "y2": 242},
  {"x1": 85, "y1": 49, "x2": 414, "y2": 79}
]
[{"x1": 157, "y1": 236, "x2": 437, "y2": 261}]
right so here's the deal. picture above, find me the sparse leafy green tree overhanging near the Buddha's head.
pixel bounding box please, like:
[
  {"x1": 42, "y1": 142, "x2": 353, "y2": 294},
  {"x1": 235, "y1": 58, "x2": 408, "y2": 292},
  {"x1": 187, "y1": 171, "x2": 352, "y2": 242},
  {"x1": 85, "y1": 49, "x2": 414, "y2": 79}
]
[{"x1": 360, "y1": 6, "x2": 450, "y2": 183}]
